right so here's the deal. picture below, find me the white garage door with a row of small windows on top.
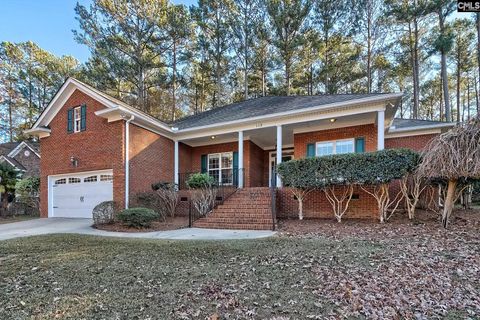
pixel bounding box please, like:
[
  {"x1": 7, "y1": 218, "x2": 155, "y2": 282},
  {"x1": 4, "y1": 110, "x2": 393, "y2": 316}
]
[{"x1": 49, "y1": 170, "x2": 113, "y2": 218}]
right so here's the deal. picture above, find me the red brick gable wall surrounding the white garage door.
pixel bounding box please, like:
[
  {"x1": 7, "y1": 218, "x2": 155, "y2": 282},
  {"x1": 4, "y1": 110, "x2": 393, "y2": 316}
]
[{"x1": 40, "y1": 90, "x2": 125, "y2": 217}]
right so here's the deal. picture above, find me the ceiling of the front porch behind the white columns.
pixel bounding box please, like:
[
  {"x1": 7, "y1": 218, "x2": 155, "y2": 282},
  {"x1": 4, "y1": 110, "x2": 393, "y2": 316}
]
[{"x1": 181, "y1": 112, "x2": 377, "y2": 150}]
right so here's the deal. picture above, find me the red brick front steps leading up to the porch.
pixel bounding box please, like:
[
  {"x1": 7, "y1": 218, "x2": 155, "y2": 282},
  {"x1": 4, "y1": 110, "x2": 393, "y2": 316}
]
[{"x1": 193, "y1": 187, "x2": 273, "y2": 230}]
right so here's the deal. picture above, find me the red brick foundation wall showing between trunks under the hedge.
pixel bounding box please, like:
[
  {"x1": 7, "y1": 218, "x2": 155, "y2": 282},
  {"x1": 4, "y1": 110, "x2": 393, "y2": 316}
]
[{"x1": 277, "y1": 188, "x2": 378, "y2": 219}]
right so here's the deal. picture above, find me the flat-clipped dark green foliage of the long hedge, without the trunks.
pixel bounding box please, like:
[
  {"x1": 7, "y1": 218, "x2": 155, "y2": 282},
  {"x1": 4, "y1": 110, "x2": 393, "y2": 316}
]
[{"x1": 277, "y1": 149, "x2": 420, "y2": 189}]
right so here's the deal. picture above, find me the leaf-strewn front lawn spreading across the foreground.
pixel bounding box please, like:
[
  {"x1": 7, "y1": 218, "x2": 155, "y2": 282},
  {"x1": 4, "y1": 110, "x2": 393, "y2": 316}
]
[{"x1": 0, "y1": 211, "x2": 480, "y2": 320}]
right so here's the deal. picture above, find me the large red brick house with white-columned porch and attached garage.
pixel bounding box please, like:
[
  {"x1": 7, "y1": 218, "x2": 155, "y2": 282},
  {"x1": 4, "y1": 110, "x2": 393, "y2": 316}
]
[{"x1": 28, "y1": 78, "x2": 452, "y2": 228}]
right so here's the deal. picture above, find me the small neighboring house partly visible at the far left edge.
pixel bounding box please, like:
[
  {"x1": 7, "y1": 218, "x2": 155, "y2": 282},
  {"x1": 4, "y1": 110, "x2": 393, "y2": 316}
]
[{"x1": 0, "y1": 141, "x2": 40, "y2": 177}]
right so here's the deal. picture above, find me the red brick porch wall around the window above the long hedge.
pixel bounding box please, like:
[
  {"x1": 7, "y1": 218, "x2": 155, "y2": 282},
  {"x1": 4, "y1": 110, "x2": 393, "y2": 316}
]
[{"x1": 293, "y1": 124, "x2": 377, "y2": 159}]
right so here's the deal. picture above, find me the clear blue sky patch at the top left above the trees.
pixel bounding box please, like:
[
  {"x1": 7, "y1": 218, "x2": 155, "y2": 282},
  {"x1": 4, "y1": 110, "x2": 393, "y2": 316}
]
[{"x1": 0, "y1": 0, "x2": 196, "y2": 62}]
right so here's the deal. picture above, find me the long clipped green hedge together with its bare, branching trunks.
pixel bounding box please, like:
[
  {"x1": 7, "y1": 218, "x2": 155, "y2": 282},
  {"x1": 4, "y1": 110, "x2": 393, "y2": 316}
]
[{"x1": 277, "y1": 149, "x2": 420, "y2": 222}]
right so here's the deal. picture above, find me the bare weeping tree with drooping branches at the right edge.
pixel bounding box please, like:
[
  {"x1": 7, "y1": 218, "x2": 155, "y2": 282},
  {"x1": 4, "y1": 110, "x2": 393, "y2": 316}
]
[{"x1": 419, "y1": 118, "x2": 480, "y2": 228}]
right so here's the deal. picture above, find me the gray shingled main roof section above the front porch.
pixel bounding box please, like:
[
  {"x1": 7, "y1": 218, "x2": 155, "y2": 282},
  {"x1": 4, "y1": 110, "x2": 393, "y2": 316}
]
[{"x1": 172, "y1": 93, "x2": 398, "y2": 130}]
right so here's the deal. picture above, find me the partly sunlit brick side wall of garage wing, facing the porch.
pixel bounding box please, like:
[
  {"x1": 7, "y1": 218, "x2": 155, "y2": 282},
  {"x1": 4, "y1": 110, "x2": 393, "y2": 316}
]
[{"x1": 129, "y1": 125, "x2": 174, "y2": 198}]
